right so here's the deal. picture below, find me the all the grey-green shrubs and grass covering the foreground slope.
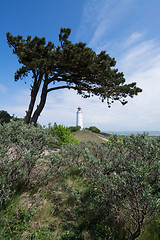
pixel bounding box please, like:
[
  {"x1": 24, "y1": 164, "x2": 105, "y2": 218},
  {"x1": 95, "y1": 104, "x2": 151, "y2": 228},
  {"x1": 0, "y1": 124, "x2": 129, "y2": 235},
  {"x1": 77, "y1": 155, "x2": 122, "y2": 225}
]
[{"x1": 0, "y1": 120, "x2": 160, "y2": 240}]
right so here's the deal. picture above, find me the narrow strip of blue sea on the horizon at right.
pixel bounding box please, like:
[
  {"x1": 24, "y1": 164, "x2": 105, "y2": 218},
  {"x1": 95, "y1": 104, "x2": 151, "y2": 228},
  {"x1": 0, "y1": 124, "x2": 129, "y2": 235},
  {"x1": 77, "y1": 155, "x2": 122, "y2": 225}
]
[{"x1": 105, "y1": 131, "x2": 160, "y2": 136}]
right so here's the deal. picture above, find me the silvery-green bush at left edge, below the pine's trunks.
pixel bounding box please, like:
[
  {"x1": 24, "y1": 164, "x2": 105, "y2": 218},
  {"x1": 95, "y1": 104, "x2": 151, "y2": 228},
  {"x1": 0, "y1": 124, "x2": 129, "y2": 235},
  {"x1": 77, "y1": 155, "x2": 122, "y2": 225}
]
[{"x1": 0, "y1": 120, "x2": 54, "y2": 207}]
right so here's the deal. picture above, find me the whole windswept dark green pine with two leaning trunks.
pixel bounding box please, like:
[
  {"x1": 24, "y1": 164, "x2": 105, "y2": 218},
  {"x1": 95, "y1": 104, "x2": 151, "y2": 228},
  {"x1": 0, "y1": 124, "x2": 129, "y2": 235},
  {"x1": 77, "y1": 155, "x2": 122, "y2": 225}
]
[{"x1": 6, "y1": 28, "x2": 142, "y2": 124}]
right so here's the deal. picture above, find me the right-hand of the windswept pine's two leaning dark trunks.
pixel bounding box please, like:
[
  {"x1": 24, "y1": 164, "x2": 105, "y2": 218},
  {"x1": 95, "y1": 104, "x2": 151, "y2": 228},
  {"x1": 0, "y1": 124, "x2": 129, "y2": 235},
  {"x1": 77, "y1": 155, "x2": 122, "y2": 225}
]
[{"x1": 30, "y1": 79, "x2": 48, "y2": 124}]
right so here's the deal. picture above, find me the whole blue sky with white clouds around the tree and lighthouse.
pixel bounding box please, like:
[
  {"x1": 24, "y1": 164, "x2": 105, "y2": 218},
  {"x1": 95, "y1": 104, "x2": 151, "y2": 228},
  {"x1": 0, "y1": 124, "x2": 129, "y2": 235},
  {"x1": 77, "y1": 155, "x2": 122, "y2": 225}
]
[{"x1": 0, "y1": 0, "x2": 160, "y2": 131}]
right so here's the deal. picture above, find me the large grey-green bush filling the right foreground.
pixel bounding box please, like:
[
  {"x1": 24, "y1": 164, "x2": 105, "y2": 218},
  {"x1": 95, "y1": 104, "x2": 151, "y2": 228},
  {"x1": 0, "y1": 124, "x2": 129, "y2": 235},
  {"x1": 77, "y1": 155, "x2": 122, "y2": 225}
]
[{"x1": 47, "y1": 134, "x2": 160, "y2": 240}]
